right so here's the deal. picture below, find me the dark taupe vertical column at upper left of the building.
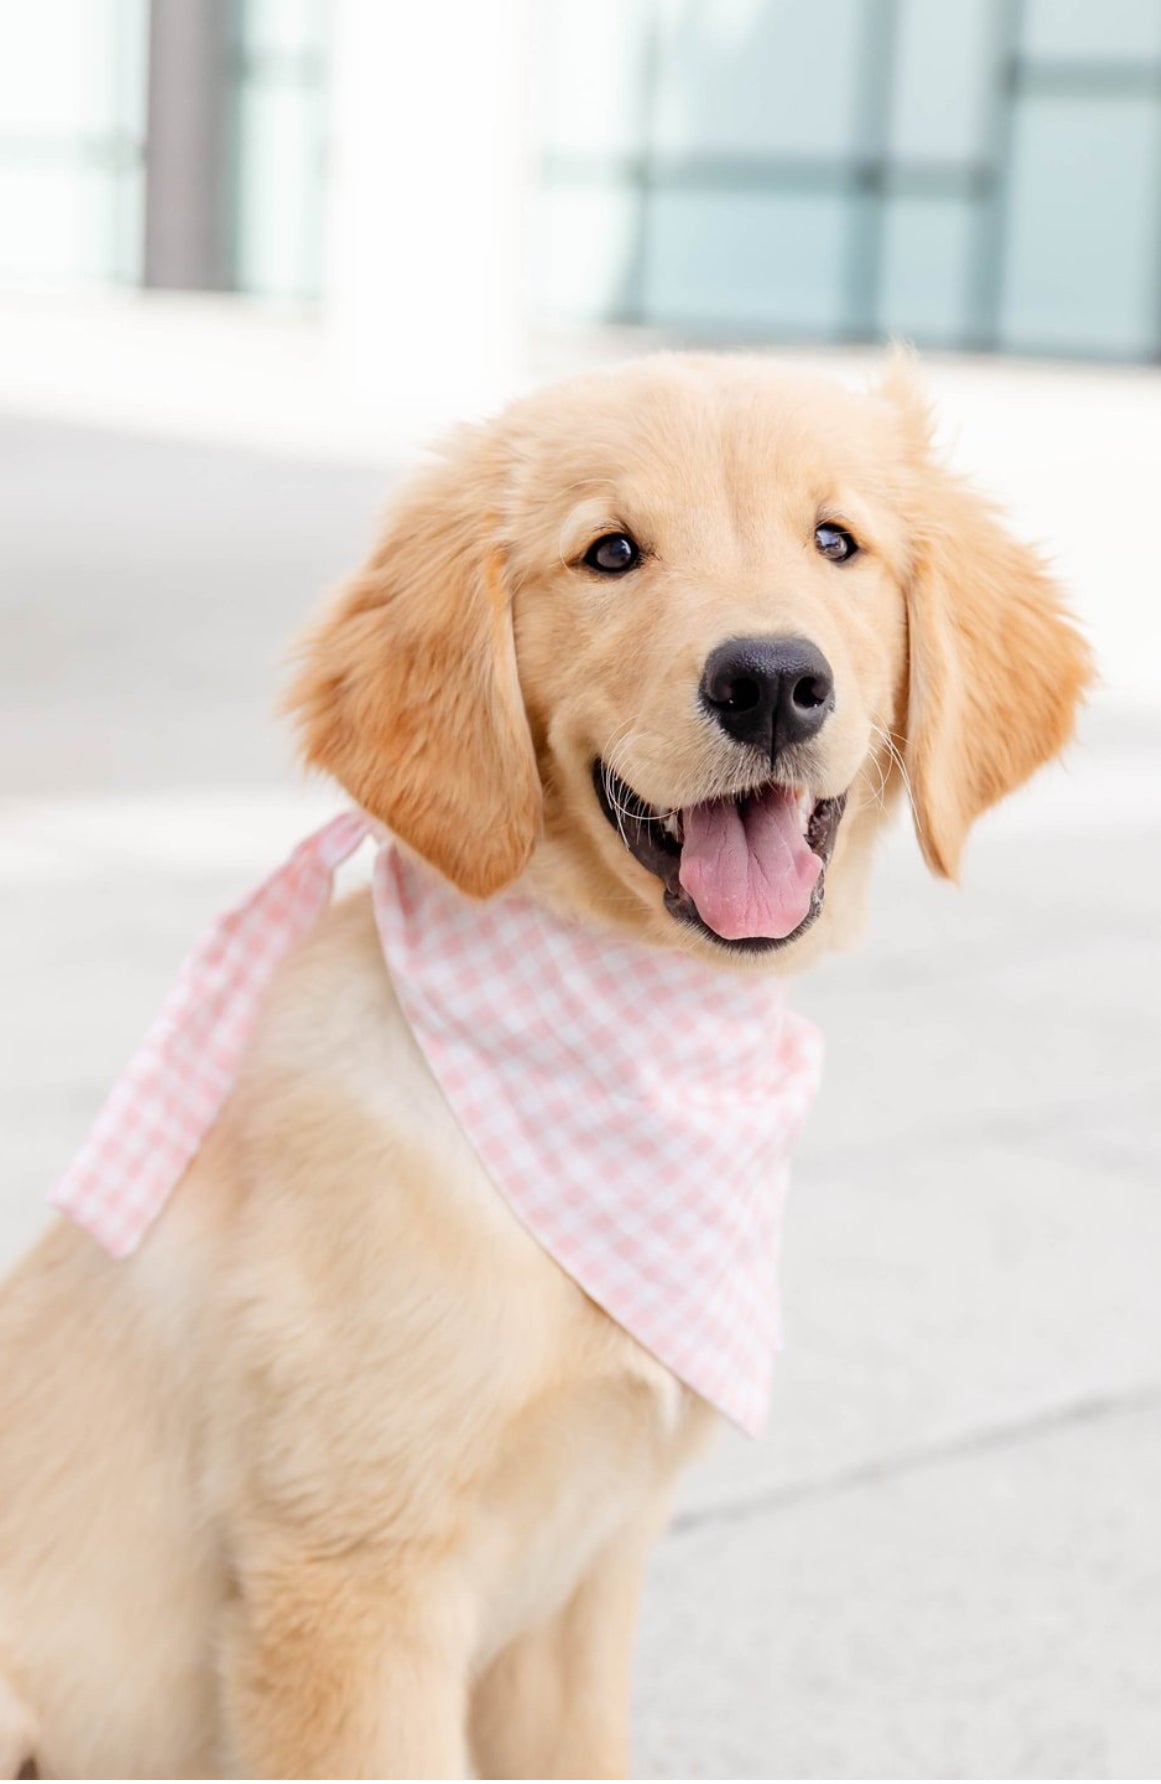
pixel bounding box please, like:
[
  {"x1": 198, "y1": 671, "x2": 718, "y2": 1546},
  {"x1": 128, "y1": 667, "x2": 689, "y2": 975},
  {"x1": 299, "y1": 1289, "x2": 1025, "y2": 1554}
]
[{"x1": 143, "y1": 0, "x2": 232, "y2": 291}]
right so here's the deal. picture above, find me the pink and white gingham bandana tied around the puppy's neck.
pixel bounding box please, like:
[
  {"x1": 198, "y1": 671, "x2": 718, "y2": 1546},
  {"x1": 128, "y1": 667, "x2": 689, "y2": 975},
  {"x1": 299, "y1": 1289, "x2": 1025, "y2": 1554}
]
[{"x1": 52, "y1": 812, "x2": 820, "y2": 1434}]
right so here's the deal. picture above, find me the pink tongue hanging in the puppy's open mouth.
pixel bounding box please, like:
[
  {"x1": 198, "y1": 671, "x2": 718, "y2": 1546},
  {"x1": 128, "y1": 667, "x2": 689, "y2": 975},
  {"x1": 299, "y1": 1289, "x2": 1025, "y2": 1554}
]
[{"x1": 679, "y1": 787, "x2": 822, "y2": 942}]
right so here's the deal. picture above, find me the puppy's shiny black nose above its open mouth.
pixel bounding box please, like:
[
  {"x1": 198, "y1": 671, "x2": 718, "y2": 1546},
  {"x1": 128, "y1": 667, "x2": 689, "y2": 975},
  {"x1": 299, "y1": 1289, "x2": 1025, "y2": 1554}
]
[{"x1": 701, "y1": 639, "x2": 835, "y2": 762}]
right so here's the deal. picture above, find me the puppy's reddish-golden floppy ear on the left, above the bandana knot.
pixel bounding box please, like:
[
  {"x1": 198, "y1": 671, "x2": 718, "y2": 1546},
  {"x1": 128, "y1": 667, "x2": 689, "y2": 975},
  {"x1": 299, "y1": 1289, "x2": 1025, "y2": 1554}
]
[{"x1": 287, "y1": 430, "x2": 540, "y2": 897}]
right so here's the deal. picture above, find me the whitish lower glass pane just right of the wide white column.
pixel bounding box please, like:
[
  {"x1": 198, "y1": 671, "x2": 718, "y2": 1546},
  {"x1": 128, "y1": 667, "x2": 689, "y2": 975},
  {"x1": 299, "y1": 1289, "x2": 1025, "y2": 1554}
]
[{"x1": 535, "y1": 186, "x2": 638, "y2": 321}]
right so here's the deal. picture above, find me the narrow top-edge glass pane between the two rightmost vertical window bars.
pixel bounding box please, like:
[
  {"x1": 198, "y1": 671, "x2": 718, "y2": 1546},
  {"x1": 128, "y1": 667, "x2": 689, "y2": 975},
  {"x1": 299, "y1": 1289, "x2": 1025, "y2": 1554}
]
[{"x1": 888, "y1": 0, "x2": 999, "y2": 161}]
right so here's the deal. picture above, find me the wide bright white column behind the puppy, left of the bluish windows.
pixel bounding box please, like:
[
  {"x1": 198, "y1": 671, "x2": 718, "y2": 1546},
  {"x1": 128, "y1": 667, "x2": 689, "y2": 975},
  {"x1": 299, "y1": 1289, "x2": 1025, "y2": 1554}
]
[{"x1": 326, "y1": 0, "x2": 530, "y2": 430}]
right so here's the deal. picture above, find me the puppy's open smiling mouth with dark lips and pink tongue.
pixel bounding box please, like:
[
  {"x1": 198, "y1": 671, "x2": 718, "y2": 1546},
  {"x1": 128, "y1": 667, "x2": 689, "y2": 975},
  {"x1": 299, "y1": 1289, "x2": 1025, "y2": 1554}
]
[{"x1": 592, "y1": 758, "x2": 847, "y2": 954}]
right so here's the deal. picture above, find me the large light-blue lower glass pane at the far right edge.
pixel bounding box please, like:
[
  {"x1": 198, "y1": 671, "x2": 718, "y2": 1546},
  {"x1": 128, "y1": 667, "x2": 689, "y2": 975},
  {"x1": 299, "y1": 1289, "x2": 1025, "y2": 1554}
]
[{"x1": 1002, "y1": 95, "x2": 1161, "y2": 353}]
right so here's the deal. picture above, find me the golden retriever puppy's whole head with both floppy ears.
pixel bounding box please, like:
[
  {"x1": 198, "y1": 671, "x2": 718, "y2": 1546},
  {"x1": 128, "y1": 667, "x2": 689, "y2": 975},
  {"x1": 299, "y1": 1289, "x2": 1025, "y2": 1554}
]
[{"x1": 291, "y1": 355, "x2": 1090, "y2": 967}]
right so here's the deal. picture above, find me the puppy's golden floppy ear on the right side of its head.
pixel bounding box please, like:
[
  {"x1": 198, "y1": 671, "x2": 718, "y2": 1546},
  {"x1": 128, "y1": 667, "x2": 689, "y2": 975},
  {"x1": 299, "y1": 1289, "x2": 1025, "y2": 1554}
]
[{"x1": 881, "y1": 359, "x2": 1093, "y2": 880}]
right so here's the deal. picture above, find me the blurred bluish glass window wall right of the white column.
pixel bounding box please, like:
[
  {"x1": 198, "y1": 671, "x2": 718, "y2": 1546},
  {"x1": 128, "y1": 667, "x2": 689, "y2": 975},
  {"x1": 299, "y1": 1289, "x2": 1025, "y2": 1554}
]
[{"x1": 537, "y1": 0, "x2": 1161, "y2": 359}]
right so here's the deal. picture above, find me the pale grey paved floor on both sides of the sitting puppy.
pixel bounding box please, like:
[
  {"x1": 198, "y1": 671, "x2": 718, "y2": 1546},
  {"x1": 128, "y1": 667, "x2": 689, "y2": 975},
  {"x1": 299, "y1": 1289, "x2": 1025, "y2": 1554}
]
[{"x1": 0, "y1": 413, "x2": 1161, "y2": 1777}]
